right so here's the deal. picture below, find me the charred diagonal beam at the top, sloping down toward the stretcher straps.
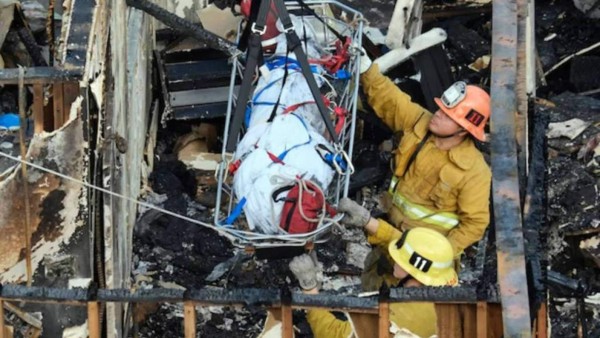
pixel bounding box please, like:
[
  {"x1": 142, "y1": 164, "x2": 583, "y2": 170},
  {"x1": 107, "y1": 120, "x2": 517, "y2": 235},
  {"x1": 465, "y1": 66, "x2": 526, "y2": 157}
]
[{"x1": 126, "y1": 0, "x2": 237, "y2": 55}]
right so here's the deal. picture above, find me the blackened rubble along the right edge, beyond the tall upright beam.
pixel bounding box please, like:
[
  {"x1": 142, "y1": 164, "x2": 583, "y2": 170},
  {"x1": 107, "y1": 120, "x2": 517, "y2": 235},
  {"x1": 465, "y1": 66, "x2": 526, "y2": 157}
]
[{"x1": 534, "y1": 1, "x2": 600, "y2": 337}]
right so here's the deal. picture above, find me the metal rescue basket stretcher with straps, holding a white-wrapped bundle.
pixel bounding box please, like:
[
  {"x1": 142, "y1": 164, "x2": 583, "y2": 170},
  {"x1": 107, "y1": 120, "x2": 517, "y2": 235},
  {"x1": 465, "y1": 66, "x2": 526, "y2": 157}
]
[{"x1": 214, "y1": 0, "x2": 364, "y2": 248}]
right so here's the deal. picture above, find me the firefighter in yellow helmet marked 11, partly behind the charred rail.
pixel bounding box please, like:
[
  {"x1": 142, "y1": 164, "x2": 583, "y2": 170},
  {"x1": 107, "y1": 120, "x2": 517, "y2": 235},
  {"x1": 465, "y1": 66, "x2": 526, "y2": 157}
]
[{"x1": 290, "y1": 219, "x2": 457, "y2": 338}]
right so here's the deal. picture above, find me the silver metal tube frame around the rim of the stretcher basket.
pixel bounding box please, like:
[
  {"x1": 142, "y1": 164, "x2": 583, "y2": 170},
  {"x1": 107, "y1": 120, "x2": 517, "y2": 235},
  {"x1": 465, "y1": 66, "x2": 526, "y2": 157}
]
[{"x1": 214, "y1": 0, "x2": 364, "y2": 248}]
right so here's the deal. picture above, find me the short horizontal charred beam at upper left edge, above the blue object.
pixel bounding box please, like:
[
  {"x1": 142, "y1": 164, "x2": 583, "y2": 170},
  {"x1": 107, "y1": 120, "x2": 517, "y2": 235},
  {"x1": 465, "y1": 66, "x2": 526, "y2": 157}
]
[{"x1": 0, "y1": 67, "x2": 83, "y2": 85}]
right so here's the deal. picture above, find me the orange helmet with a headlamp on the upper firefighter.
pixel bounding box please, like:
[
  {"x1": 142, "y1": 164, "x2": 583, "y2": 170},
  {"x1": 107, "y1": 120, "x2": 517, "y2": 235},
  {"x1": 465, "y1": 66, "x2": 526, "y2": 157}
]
[{"x1": 434, "y1": 81, "x2": 491, "y2": 141}]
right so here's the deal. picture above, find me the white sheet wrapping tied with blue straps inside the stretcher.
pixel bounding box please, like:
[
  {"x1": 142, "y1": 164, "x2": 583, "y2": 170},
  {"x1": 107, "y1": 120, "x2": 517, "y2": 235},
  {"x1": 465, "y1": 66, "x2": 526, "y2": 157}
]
[{"x1": 233, "y1": 16, "x2": 334, "y2": 234}]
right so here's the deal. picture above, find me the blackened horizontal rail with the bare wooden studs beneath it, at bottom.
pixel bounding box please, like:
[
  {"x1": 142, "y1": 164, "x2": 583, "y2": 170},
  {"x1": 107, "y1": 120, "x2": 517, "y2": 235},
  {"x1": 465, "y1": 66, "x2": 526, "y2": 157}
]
[{"x1": 0, "y1": 284, "x2": 501, "y2": 338}]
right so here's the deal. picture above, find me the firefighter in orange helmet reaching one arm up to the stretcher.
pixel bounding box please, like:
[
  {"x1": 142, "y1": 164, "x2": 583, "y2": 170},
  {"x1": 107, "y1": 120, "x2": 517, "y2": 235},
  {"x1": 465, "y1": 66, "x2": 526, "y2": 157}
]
[{"x1": 350, "y1": 49, "x2": 491, "y2": 290}]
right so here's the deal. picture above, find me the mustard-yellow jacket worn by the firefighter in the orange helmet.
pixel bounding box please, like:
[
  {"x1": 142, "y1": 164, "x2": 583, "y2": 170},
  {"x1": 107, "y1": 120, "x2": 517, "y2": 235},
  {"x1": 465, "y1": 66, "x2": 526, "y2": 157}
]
[{"x1": 361, "y1": 64, "x2": 491, "y2": 254}]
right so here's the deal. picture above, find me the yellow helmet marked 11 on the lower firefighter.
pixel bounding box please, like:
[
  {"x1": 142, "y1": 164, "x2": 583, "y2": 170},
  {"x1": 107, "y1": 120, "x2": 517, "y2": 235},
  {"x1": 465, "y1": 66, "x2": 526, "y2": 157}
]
[{"x1": 388, "y1": 228, "x2": 458, "y2": 286}]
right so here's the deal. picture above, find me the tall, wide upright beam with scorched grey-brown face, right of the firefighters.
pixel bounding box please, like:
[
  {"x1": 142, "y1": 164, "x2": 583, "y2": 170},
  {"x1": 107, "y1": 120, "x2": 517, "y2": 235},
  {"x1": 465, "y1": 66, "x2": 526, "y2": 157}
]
[{"x1": 491, "y1": 0, "x2": 531, "y2": 337}]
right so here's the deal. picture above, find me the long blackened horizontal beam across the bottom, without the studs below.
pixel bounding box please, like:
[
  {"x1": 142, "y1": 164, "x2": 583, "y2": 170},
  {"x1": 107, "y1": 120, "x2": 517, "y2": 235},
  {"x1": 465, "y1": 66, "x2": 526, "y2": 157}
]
[{"x1": 0, "y1": 284, "x2": 498, "y2": 304}]
